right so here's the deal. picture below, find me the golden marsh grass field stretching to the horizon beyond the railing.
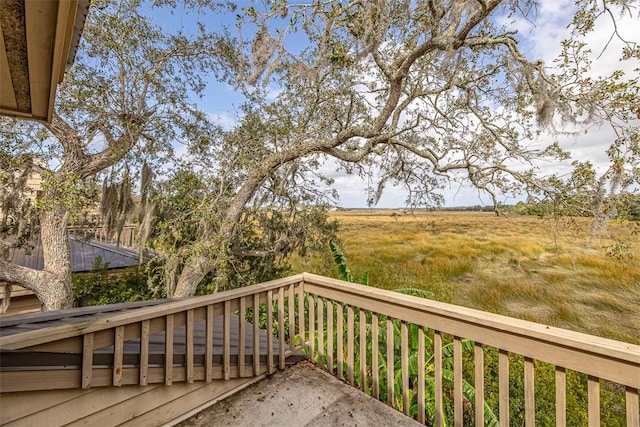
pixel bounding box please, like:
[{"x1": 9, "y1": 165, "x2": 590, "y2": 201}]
[{"x1": 292, "y1": 210, "x2": 640, "y2": 343}]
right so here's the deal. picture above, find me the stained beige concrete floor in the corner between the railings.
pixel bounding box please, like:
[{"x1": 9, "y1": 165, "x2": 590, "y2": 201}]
[{"x1": 179, "y1": 361, "x2": 420, "y2": 427}]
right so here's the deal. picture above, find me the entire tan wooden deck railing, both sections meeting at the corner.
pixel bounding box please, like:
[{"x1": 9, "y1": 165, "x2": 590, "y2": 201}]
[{"x1": 0, "y1": 273, "x2": 640, "y2": 427}]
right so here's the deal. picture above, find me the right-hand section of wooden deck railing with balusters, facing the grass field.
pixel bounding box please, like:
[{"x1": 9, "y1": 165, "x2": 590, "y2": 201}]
[{"x1": 304, "y1": 274, "x2": 640, "y2": 427}]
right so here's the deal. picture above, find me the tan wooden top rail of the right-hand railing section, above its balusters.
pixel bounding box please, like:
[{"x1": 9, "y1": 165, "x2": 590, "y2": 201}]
[{"x1": 303, "y1": 273, "x2": 640, "y2": 388}]
